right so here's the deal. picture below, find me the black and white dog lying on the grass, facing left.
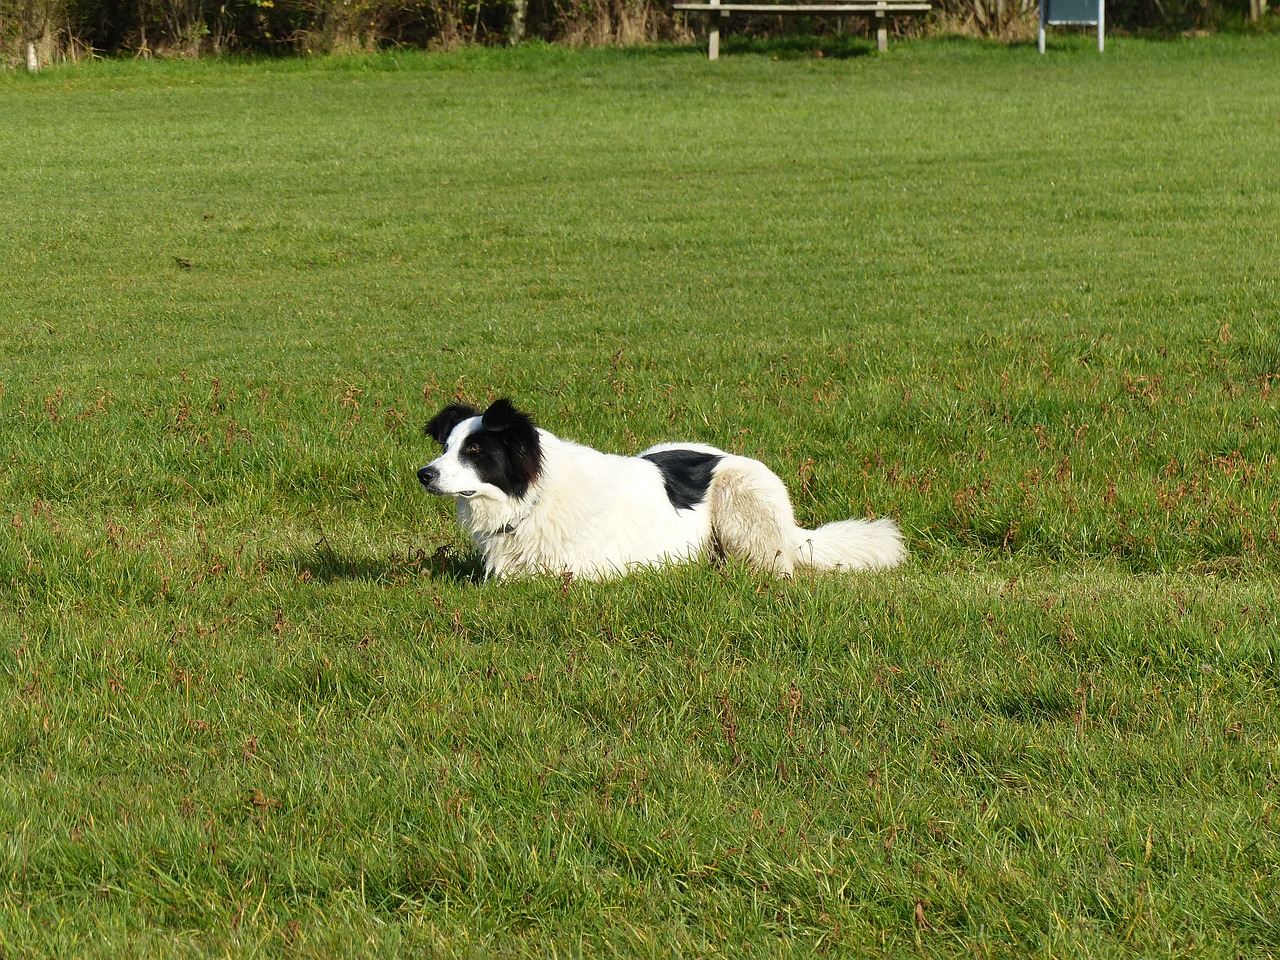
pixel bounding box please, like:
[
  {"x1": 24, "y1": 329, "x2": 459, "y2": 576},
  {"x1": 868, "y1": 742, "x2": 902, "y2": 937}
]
[{"x1": 417, "y1": 399, "x2": 906, "y2": 577}]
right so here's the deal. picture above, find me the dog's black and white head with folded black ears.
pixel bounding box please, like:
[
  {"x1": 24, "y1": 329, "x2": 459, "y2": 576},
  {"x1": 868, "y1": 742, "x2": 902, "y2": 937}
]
[{"x1": 417, "y1": 399, "x2": 543, "y2": 500}]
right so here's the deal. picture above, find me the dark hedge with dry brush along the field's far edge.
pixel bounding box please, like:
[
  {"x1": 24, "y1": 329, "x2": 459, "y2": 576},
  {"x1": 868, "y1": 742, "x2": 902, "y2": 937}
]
[{"x1": 0, "y1": 0, "x2": 1262, "y2": 69}]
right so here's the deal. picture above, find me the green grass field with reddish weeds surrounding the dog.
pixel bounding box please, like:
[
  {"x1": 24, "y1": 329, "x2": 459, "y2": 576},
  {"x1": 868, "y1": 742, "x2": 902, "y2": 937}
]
[{"x1": 0, "y1": 35, "x2": 1280, "y2": 957}]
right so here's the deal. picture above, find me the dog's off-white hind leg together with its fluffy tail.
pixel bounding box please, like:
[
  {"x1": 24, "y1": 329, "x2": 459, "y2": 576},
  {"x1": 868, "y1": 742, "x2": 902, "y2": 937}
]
[{"x1": 710, "y1": 457, "x2": 906, "y2": 576}]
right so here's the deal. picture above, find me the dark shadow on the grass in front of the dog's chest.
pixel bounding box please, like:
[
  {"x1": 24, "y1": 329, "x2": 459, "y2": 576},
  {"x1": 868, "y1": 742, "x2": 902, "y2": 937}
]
[{"x1": 266, "y1": 539, "x2": 484, "y2": 585}]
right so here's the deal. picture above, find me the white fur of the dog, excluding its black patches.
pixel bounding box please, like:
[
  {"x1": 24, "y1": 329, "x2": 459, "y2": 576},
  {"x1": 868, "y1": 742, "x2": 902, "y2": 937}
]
[{"x1": 430, "y1": 417, "x2": 906, "y2": 579}]
